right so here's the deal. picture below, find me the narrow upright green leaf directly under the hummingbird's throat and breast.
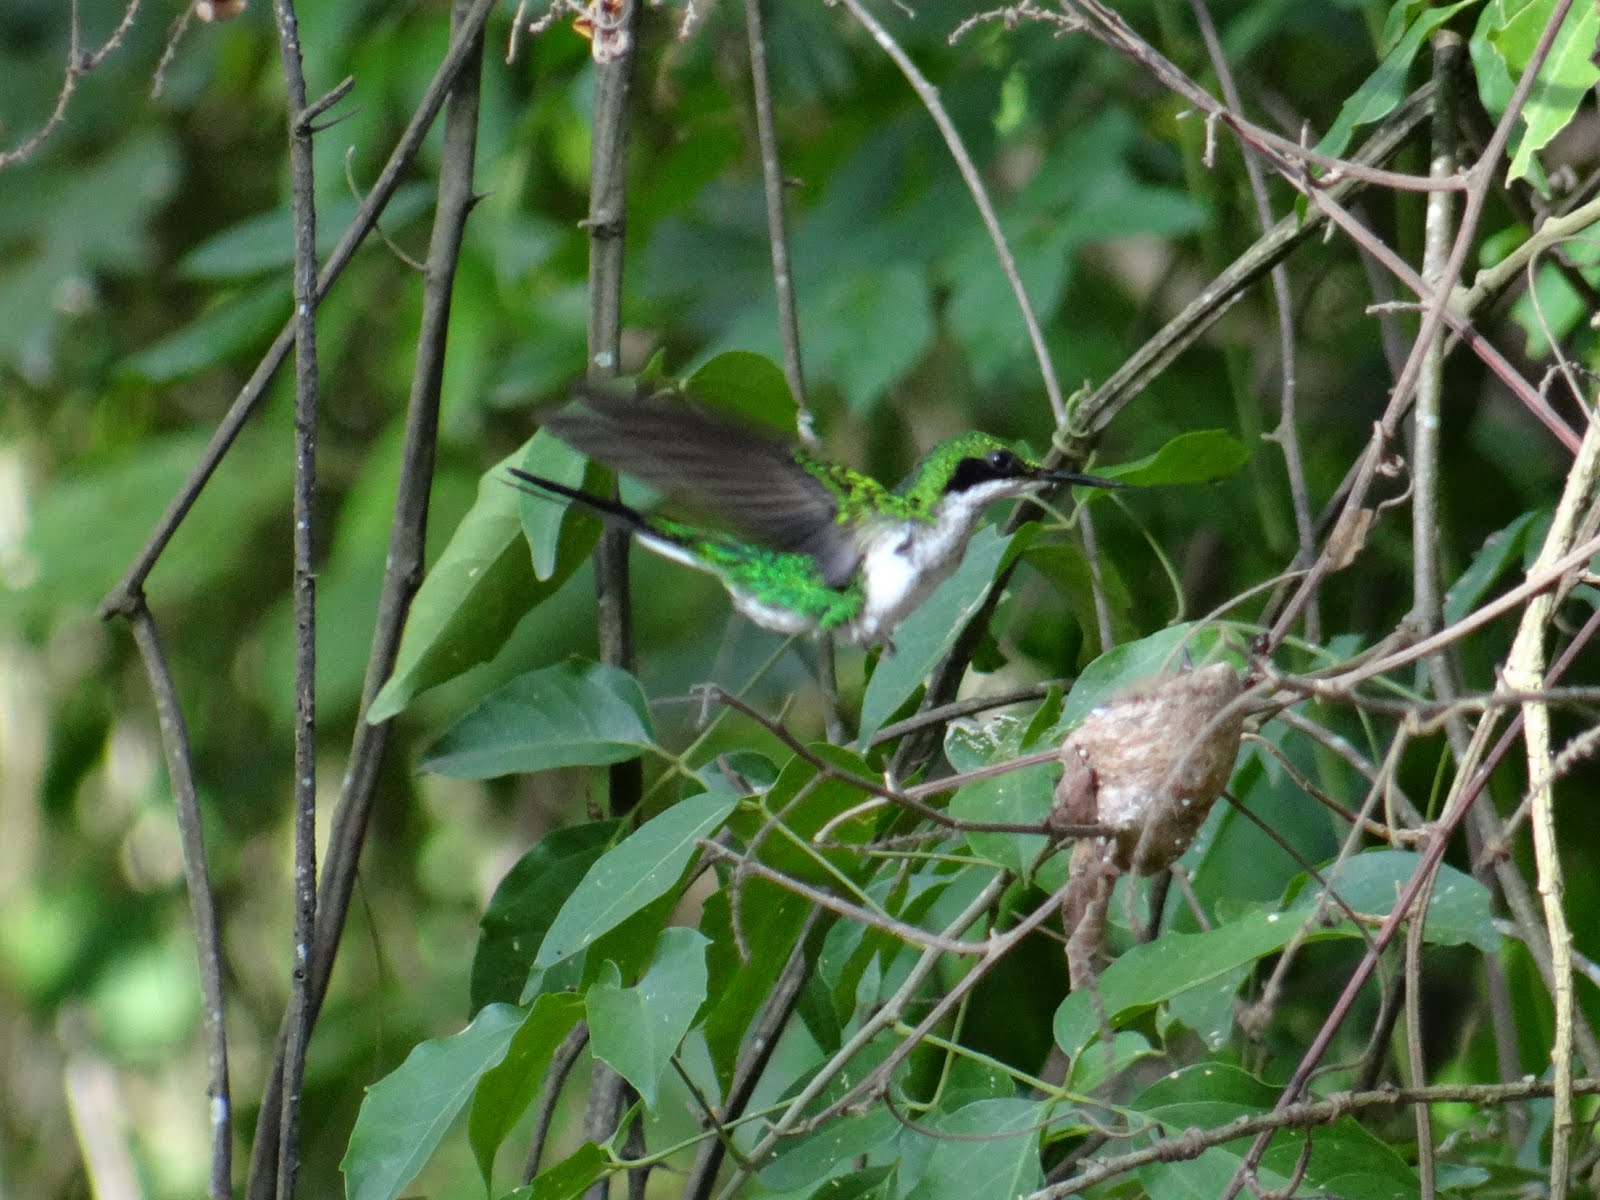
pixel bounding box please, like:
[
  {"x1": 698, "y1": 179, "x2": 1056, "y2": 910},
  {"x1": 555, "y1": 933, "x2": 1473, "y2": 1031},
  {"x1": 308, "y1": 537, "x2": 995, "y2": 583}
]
[{"x1": 861, "y1": 526, "x2": 1021, "y2": 742}]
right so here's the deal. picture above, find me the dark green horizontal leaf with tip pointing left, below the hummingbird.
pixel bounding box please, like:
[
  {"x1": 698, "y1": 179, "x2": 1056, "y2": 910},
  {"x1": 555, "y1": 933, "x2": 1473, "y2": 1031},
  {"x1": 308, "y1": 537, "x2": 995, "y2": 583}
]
[{"x1": 422, "y1": 662, "x2": 654, "y2": 779}]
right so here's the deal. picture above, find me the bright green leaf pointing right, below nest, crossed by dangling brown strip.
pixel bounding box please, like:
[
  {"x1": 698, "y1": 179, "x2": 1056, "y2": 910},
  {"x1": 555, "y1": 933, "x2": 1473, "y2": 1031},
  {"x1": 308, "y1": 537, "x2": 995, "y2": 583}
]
[{"x1": 1054, "y1": 912, "x2": 1305, "y2": 1058}]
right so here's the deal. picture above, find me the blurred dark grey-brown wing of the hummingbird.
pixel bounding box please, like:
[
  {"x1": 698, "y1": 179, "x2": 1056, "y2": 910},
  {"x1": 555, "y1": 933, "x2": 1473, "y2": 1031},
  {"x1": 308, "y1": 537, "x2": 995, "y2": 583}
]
[{"x1": 544, "y1": 390, "x2": 861, "y2": 587}]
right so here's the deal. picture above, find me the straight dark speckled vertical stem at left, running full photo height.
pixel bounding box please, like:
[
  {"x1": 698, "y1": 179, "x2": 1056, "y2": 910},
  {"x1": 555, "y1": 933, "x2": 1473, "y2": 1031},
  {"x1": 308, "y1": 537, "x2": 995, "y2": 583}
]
[{"x1": 272, "y1": 0, "x2": 317, "y2": 1200}]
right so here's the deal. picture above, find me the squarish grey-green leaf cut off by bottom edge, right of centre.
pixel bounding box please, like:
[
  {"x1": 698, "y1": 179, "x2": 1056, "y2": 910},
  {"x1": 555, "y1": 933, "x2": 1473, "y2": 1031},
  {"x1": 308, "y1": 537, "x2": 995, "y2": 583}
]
[{"x1": 910, "y1": 1099, "x2": 1045, "y2": 1200}]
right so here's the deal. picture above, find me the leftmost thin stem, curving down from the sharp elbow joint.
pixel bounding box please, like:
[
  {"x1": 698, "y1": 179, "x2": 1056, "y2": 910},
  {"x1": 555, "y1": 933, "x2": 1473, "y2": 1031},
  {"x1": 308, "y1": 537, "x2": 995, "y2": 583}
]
[{"x1": 131, "y1": 605, "x2": 234, "y2": 1200}]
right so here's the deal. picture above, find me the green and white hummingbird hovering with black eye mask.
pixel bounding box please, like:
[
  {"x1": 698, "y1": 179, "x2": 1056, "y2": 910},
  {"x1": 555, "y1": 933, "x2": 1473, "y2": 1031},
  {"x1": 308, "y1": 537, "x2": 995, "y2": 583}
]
[{"x1": 510, "y1": 389, "x2": 1123, "y2": 650}]
